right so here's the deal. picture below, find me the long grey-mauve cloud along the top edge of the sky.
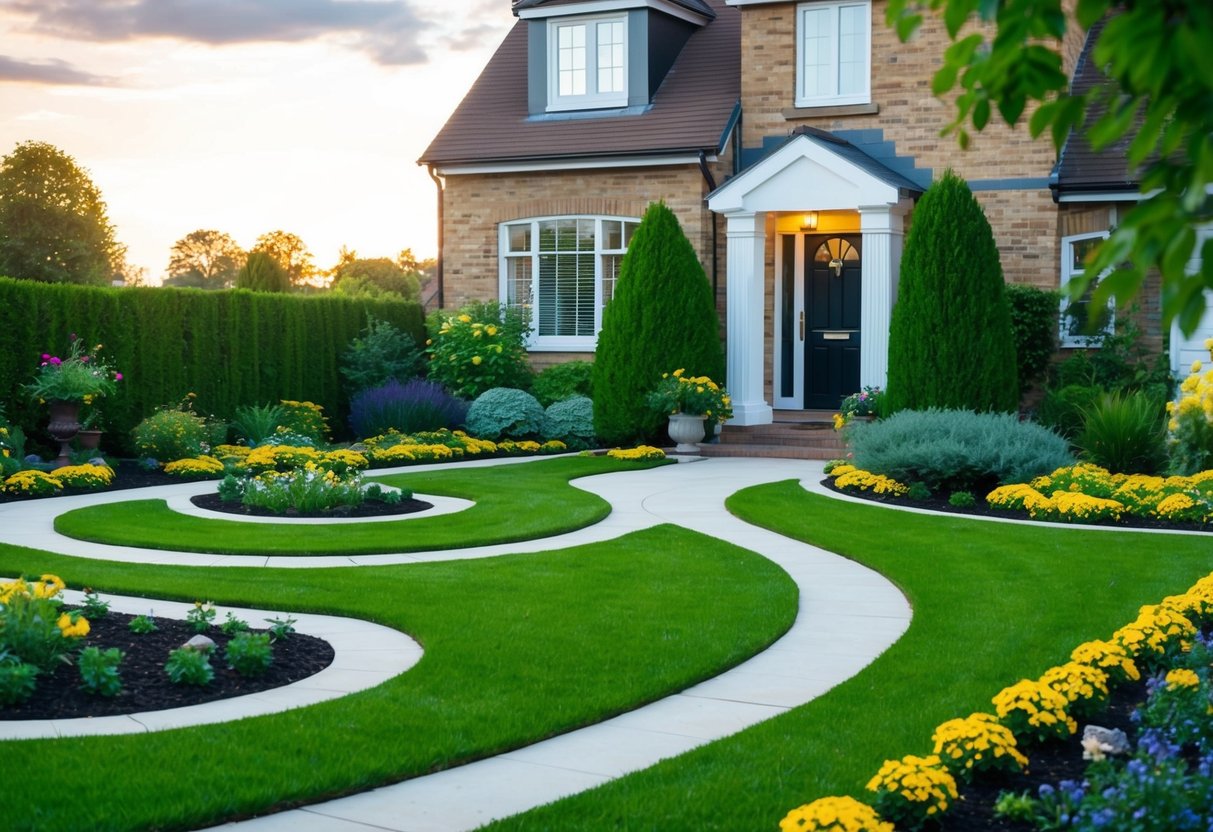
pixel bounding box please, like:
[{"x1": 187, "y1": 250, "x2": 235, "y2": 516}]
[{"x1": 0, "y1": 0, "x2": 432, "y2": 65}]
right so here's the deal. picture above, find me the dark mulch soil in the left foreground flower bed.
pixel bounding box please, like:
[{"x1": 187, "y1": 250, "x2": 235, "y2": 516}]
[{"x1": 0, "y1": 608, "x2": 334, "y2": 720}]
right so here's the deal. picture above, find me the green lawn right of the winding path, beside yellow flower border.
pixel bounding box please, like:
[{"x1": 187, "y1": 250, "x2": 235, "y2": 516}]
[{"x1": 486, "y1": 481, "x2": 1213, "y2": 832}]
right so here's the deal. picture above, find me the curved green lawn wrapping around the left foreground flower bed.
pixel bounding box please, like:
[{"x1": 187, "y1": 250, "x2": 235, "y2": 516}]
[{"x1": 0, "y1": 523, "x2": 797, "y2": 832}]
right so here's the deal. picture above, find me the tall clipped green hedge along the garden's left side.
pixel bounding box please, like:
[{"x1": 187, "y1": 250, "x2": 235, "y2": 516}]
[{"x1": 0, "y1": 278, "x2": 426, "y2": 446}]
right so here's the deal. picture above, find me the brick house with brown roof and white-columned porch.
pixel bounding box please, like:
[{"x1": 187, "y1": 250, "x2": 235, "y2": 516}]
[{"x1": 420, "y1": 0, "x2": 1198, "y2": 426}]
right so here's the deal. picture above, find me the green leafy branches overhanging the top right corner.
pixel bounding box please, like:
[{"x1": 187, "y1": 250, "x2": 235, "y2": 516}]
[{"x1": 885, "y1": 0, "x2": 1213, "y2": 335}]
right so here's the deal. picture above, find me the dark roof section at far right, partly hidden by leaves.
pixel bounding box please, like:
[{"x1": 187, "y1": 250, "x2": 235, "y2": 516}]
[{"x1": 1053, "y1": 18, "x2": 1139, "y2": 194}]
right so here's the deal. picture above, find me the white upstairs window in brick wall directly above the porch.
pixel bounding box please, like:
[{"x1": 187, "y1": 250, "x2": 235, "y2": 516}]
[{"x1": 796, "y1": 0, "x2": 872, "y2": 107}]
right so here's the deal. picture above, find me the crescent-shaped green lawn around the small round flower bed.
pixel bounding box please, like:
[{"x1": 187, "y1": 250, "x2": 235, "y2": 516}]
[{"x1": 55, "y1": 456, "x2": 660, "y2": 554}]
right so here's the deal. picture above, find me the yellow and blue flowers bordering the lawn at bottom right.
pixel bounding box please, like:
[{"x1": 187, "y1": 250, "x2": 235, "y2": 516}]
[{"x1": 780, "y1": 575, "x2": 1213, "y2": 832}]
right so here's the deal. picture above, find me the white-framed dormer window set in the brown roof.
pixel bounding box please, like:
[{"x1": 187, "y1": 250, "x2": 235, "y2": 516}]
[{"x1": 547, "y1": 15, "x2": 627, "y2": 112}]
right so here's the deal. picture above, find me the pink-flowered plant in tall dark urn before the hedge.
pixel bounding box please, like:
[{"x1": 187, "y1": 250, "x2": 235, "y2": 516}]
[{"x1": 25, "y1": 332, "x2": 123, "y2": 466}]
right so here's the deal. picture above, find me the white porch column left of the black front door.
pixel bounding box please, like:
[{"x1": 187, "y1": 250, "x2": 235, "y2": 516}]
[{"x1": 725, "y1": 211, "x2": 774, "y2": 426}]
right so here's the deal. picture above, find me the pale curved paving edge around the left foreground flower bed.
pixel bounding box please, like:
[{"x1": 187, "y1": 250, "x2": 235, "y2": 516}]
[{"x1": 0, "y1": 591, "x2": 422, "y2": 748}]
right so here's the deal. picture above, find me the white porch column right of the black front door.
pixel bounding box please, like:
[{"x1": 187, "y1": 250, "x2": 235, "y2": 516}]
[{"x1": 859, "y1": 203, "x2": 909, "y2": 388}]
